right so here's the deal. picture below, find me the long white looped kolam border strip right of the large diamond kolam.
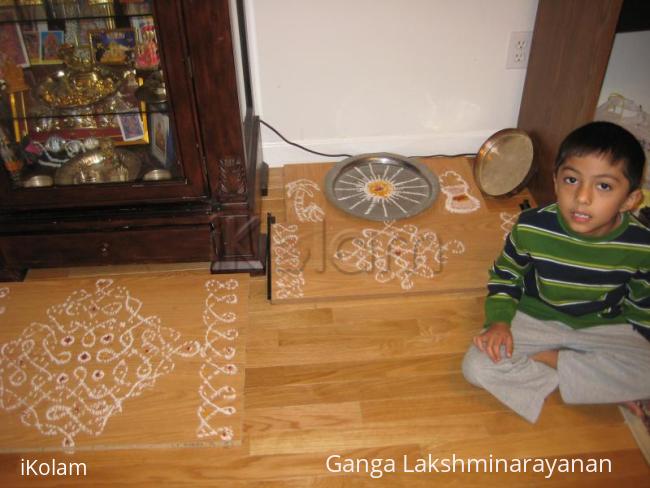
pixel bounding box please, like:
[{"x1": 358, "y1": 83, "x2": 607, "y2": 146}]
[{"x1": 196, "y1": 279, "x2": 239, "y2": 442}]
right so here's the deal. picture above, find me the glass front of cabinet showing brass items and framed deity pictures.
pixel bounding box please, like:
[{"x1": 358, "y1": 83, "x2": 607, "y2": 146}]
[{"x1": 0, "y1": 0, "x2": 201, "y2": 206}]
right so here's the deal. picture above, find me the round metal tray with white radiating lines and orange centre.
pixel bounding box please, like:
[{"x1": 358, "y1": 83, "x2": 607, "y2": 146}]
[{"x1": 325, "y1": 153, "x2": 440, "y2": 221}]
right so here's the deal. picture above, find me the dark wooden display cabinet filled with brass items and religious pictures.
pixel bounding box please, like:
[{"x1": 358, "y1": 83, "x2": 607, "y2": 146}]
[{"x1": 0, "y1": 0, "x2": 266, "y2": 281}]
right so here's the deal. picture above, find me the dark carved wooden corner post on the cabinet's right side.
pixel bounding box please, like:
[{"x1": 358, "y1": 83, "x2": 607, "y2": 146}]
[{"x1": 183, "y1": 0, "x2": 265, "y2": 272}]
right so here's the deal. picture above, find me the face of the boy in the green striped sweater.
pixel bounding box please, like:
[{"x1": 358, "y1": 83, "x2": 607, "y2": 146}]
[{"x1": 554, "y1": 154, "x2": 641, "y2": 237}]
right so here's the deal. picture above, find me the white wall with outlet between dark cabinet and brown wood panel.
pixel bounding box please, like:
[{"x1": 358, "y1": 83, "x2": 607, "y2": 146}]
[{"x1": 247, "y1": 0, "x2": 537, "y2": 166}]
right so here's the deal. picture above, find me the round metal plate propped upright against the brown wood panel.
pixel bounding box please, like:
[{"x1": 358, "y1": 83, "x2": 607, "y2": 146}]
[{"x1": 474, "y1": 129, "x2": 533, "y2": 197}]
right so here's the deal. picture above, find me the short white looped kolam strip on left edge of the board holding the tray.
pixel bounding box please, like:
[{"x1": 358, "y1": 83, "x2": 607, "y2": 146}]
[{"x1": 271, "y1": 224, "x2": 305, "y2": 299}]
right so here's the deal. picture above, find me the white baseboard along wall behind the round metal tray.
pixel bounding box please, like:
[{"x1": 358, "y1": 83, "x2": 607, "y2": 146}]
[{"x1": 262, "y1": 128, "x2": 500, "y2": 167}]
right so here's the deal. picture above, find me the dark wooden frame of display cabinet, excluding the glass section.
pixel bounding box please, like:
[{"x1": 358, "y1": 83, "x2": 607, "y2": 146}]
[{"x1": 0, "y1": 0, "x2": 266, "y2": 280}]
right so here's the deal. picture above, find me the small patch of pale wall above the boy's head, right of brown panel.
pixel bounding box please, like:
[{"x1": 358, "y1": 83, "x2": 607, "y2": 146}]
[{"x1": 598, "y1": 31, "x2": 650, "y2": 113}]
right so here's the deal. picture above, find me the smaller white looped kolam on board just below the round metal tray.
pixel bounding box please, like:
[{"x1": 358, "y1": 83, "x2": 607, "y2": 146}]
[{"x1": 334, "y1": 221, "x2": 465, "y2": 290}]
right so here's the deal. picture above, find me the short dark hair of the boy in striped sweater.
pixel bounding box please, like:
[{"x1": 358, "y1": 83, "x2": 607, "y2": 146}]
[{"x1": 555, "y1": 122, "x2": 645, "y2": 191}]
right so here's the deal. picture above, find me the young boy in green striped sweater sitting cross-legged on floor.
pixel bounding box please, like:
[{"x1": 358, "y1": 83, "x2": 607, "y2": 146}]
[{"x1": 463, "y1": 122, "x2": 650, "y2": 426}]
